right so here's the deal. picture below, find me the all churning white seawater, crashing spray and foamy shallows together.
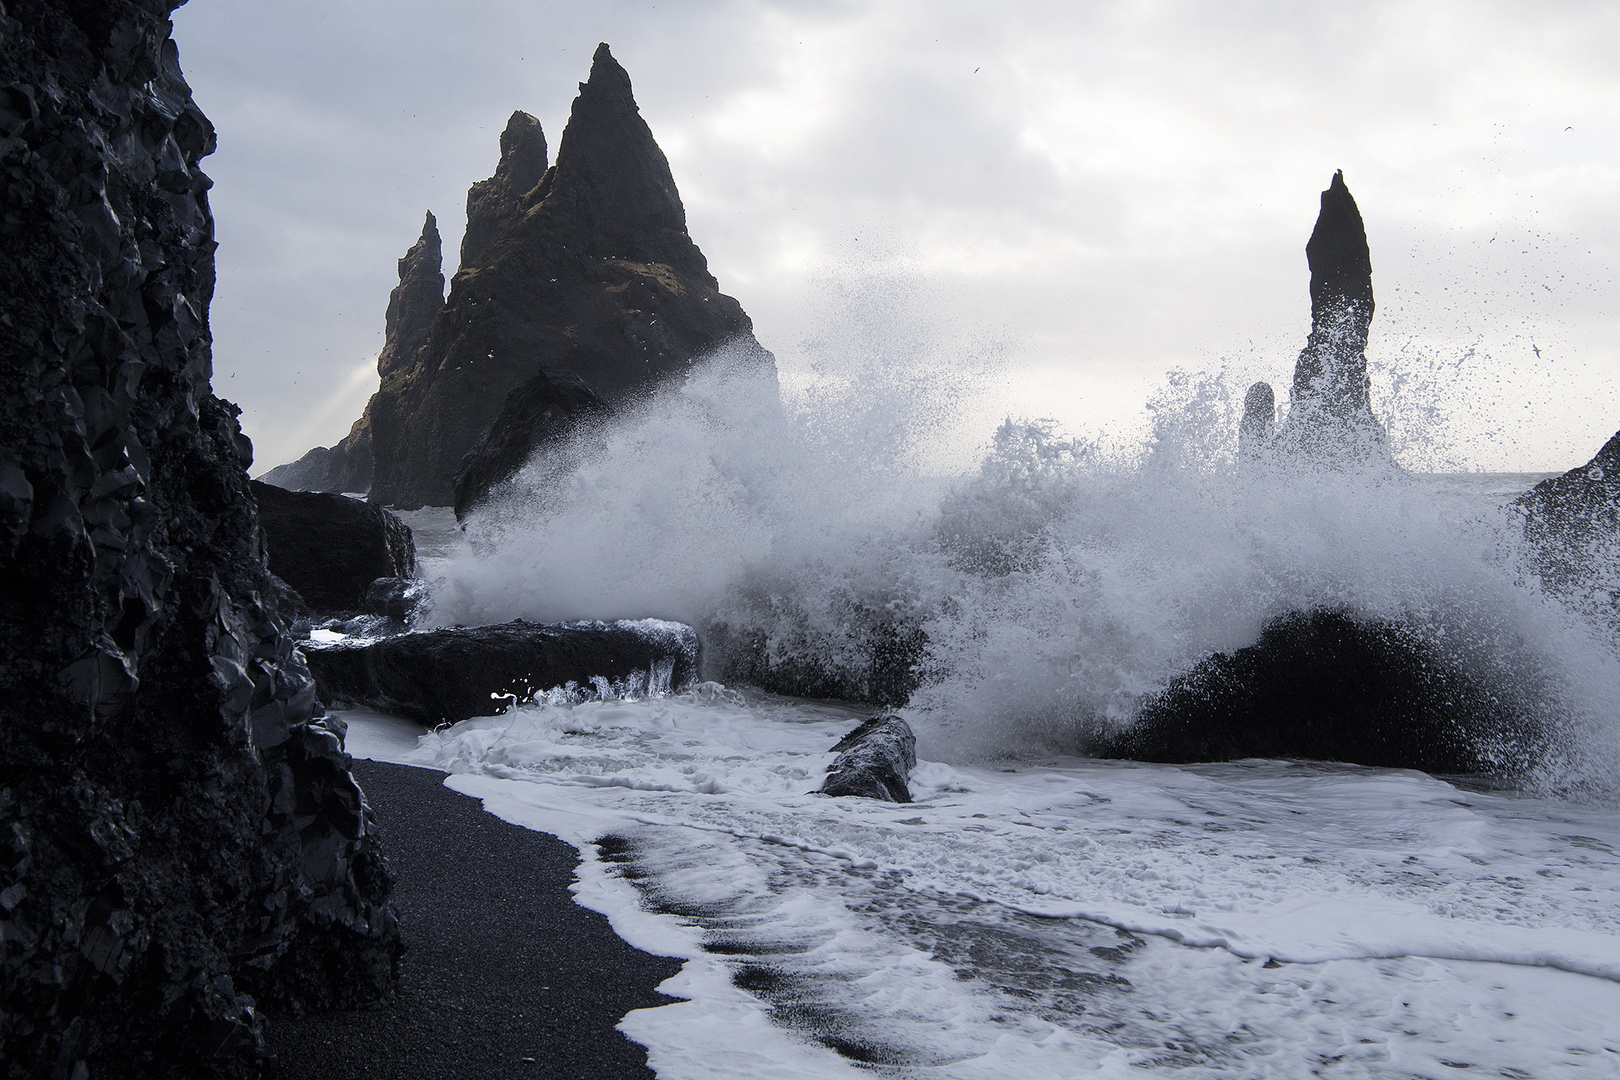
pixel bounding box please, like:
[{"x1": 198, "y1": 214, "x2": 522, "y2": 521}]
[{"x1": 358, "y1": 356, "x2": 1620, "y2": 1077}]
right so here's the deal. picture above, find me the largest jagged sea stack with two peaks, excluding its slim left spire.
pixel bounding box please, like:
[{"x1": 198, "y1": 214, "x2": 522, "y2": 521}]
[{"x1": 368, "y1": 45, "x2": 774, "y2": 508}]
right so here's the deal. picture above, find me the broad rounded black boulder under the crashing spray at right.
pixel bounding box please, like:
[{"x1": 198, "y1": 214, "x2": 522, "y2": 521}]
[{"x1": 1092, "y1": 610, "x2": 1542, "y2": 772}]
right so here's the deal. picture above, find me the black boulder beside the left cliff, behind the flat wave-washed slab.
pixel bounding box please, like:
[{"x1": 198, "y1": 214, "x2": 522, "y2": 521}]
[{"x1": 253, "y1": 481, "x2": 416, "y2": 612}]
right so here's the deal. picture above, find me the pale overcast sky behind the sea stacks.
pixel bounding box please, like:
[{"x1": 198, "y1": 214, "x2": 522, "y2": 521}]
[{"x1": 175, "y1": 0, "x2": 1620, "y2": 471}]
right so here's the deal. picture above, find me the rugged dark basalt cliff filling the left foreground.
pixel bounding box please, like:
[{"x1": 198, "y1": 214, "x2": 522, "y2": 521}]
[{"x1": 0, "y1": 0, "x2": 400, "y2": 1078}]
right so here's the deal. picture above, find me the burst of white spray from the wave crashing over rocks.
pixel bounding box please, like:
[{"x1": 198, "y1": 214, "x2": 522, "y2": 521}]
[{"x1": 431, "y1": 350, "x2": 1620, "y2": 800}]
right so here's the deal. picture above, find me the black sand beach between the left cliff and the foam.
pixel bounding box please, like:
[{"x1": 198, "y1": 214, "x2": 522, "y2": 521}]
[{"x1": 271, "y1": 761, "x2": 680, "y2": 1080}]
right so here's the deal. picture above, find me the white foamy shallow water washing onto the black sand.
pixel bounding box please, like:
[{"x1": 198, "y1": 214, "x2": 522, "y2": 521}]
[{"x1": 350, "y1": 696, "x2": 1620, "y2": 1078}]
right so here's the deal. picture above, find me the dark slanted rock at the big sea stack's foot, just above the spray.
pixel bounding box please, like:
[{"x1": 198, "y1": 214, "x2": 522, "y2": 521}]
[{"x1": 454, "y1": 364, "x2": 609, "y2": 520}]
